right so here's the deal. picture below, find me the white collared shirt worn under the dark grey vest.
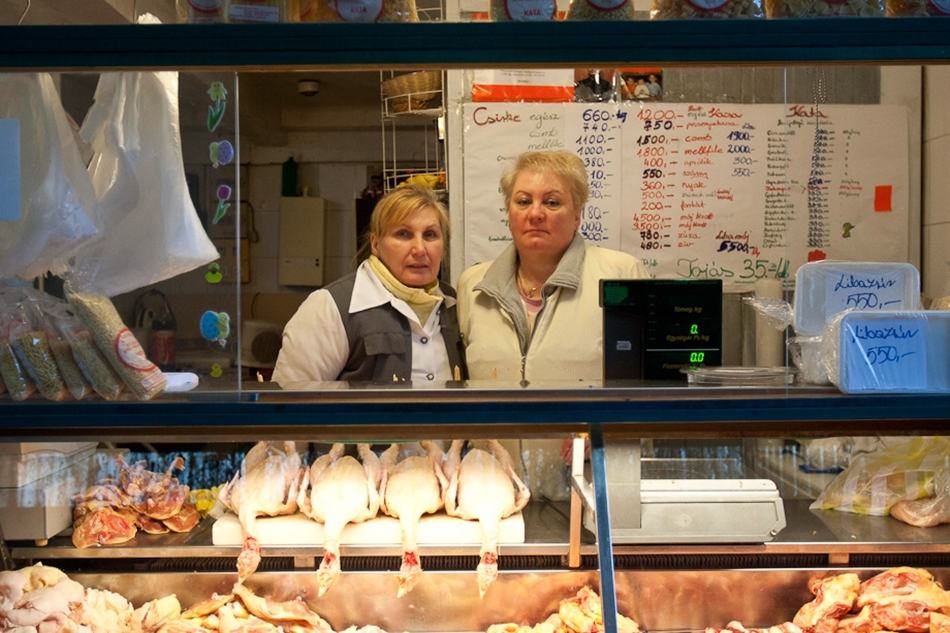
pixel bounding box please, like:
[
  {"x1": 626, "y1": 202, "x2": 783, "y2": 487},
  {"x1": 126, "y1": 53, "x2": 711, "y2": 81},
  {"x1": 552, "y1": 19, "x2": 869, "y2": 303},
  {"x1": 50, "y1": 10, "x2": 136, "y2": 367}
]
[{"x1": 272, "y1": 262, "x2": 455, "y2": 385}]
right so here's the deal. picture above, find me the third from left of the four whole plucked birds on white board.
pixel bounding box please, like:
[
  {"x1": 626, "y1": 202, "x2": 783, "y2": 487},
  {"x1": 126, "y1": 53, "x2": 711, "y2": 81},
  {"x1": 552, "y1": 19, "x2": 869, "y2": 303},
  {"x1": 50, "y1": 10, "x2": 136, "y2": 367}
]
[{"x1": 379, "y1": 442, "x2": 448, "y2": 598}]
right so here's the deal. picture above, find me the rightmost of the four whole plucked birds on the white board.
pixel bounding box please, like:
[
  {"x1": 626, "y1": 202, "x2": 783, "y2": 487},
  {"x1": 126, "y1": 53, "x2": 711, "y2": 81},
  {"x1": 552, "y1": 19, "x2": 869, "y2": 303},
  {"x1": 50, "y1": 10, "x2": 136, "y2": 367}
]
[{"x1": 442, "y1": 440, "x2": 531, "y2": 597}]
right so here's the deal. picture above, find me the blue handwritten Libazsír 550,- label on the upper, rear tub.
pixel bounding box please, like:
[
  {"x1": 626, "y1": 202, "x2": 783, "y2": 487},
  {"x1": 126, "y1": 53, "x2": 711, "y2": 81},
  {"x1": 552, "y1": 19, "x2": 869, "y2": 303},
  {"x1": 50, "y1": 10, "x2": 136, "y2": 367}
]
[{"x1": 825, "y1": 269, "x2": 911, "y2": 315}]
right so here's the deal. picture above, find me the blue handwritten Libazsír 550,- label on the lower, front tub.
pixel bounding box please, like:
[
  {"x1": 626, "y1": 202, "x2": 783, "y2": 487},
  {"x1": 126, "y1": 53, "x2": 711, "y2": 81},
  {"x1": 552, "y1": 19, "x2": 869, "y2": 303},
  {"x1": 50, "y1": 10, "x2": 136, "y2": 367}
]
[{"x1": 841, "y1": 316, "x2": 928, "y2": 392}]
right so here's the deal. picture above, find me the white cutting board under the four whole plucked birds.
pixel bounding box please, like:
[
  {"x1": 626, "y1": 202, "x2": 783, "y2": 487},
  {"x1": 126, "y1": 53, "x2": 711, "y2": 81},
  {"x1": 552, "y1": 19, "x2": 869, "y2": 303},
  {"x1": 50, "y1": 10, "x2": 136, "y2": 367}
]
[{"x1": 211, "y1": 511, "x2": 524, "y2": 547}]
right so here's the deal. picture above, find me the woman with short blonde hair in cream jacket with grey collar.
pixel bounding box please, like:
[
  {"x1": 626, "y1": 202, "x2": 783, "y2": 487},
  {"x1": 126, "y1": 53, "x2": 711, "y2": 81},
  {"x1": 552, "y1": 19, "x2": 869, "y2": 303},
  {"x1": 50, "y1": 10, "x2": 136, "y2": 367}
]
[{"x1": 458, "y1": 151, "x2": 649, "y2": 381}]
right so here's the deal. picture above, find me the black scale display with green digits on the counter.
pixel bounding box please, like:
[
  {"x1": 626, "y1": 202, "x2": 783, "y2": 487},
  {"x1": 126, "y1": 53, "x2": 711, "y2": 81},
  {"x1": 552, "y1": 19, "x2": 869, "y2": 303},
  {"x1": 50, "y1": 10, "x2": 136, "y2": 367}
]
[{"x1": 600, "y1": 279, "x2": 722, "y2": 380}]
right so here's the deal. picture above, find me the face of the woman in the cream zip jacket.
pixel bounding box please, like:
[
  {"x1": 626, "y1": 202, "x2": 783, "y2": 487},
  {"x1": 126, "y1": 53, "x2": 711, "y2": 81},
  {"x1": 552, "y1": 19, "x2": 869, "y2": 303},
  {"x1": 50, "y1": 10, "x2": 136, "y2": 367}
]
[{"x1": 508, "y1": 172, "x2": 581, "y2": 259}]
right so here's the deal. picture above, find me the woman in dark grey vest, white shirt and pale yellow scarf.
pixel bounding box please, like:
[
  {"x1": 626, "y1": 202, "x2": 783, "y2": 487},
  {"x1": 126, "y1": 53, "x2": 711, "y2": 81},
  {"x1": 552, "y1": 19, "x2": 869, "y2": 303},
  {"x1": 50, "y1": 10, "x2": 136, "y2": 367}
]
[{"x1": 273, "y1": 187, "x2": 467, "y2": 382}]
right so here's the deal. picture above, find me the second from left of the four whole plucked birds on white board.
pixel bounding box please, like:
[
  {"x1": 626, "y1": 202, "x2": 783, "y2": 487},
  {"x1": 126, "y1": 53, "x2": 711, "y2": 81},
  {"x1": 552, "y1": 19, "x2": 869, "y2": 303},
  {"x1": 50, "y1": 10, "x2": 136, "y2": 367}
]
[{"x1": 297, "y1": 444, "x2": 382, "y2": 596}]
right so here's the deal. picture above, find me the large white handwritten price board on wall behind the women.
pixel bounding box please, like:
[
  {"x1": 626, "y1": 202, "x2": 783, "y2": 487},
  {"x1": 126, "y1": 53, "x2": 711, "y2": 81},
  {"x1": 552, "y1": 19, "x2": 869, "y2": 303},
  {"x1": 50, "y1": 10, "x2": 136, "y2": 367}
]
[{"x1": 462, "y1": 102, "x2": 910, "y2": 284}]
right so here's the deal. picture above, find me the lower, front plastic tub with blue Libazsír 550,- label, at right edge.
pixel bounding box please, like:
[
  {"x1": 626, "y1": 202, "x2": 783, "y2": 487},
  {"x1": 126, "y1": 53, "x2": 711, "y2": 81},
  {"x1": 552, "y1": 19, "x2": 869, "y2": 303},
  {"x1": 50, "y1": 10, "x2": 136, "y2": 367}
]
[{"x1": 825, "y1": 310, "x2": 950, "y2": 394}]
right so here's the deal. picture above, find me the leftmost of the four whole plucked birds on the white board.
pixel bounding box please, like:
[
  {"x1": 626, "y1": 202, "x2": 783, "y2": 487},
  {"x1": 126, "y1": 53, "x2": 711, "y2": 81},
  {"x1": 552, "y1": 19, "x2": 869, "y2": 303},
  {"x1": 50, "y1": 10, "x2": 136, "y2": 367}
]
[{"x1": 218, "y1": 442, "x2": 304, "y2": 584}]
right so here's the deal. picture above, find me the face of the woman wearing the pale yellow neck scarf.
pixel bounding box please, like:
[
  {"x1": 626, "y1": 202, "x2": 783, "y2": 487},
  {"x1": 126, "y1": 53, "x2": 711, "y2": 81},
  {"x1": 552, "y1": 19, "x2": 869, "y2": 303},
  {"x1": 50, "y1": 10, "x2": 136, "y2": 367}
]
[{"x1": 370, "y1": 207, "x2": 445, "y2": 288}]
